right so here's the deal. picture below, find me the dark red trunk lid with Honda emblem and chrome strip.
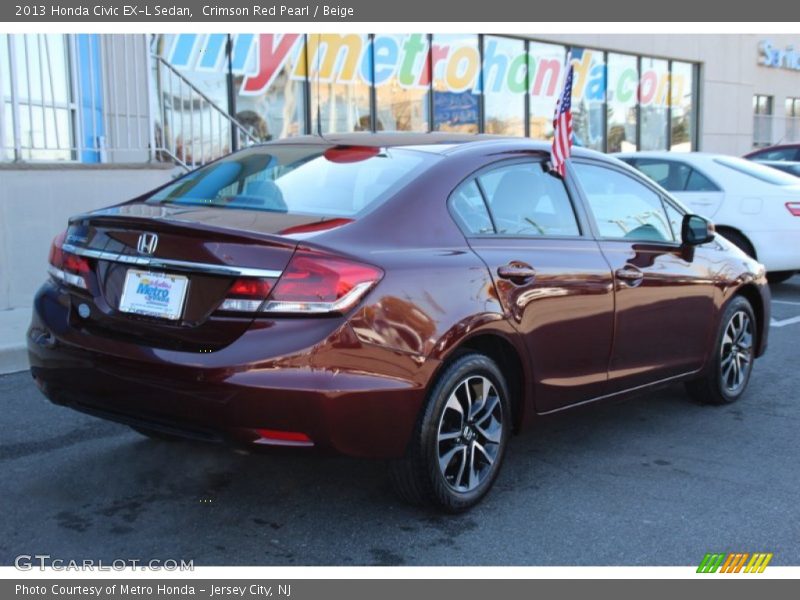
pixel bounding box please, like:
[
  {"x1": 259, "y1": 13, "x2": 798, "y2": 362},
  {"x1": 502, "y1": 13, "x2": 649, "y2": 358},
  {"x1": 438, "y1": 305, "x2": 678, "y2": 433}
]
[{"x1": 59, "y1": 203, "x2": 346, "y2": 352}]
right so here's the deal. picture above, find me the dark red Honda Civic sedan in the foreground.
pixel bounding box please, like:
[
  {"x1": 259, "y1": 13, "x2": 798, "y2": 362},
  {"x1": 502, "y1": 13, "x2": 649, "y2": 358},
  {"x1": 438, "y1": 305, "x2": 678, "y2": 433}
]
[{"x1": 28, "y1": 134, "x2": 769, "y2": 511}]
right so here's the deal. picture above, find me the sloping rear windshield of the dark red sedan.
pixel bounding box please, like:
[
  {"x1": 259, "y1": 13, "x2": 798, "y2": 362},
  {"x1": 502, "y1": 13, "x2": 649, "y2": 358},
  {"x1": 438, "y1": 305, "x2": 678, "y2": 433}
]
[{"x1": 147, "y1": 144, "x2": 432, "y2": 217}]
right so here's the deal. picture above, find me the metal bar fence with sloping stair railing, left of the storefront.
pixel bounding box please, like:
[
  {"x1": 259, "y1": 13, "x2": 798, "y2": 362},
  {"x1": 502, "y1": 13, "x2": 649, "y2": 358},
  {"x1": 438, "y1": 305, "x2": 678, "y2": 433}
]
[{"x1": 0, "y1": 34, "x2": 256, "y2": 168}]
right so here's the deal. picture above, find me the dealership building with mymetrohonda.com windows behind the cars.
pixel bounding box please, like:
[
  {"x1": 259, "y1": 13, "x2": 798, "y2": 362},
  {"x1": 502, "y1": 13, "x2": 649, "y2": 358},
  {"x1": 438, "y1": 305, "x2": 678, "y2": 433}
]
[{"x1": 0, "y1": 33, "x2": 800, "y2": 318}]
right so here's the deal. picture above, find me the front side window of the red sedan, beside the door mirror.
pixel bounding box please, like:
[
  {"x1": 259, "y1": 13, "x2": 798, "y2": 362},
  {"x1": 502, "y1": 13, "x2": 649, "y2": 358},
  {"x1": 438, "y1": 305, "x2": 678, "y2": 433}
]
[{"x1": 574, "y1": 163, "x2": 676, "y2": 242}]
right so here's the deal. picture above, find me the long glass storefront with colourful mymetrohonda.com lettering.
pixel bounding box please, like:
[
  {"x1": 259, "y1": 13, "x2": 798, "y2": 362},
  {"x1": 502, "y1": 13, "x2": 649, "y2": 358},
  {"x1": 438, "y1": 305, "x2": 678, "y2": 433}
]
[{"x1": 148, "y1": 33, "x2": 692, "y2": 152}]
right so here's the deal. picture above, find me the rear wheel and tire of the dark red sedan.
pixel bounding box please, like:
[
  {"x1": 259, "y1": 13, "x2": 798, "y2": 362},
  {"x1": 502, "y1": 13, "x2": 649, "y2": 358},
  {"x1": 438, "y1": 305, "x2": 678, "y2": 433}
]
[{"x1": 389, "y1": 353, "x2": 512, "y2": 513}]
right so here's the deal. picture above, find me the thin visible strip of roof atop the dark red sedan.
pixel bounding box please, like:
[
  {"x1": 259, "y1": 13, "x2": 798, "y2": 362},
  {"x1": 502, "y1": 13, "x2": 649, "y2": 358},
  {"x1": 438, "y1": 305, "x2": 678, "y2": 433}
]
[{"x1": 256, "y1": 131, "x2": 607, "y2": 159}]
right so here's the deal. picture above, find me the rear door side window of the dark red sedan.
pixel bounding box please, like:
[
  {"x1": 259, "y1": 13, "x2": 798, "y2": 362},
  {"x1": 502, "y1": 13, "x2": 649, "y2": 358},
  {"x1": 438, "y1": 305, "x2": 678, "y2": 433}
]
[{"x1": 478, "y1": 162, "x2": 580, "y2": 237}]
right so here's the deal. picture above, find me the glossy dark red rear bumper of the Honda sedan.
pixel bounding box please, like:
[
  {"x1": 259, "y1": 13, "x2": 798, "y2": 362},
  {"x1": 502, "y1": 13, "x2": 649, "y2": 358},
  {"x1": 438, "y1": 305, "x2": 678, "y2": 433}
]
[{"x1": 27, "y1": 285, "x2": 436, "y2": 458}]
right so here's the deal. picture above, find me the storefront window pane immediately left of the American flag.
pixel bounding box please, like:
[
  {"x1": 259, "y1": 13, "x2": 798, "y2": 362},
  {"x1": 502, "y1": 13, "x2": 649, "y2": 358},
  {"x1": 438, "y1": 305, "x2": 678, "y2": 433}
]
[{"x1": 528, "y1": 42, "x2": 567, "y2": 140}]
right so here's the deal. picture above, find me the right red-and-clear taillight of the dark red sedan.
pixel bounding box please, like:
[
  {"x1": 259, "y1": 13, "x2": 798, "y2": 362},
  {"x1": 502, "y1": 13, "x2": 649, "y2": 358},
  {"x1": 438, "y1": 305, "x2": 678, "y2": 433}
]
[{"x1": 261, "y1": 251, "x2": 383, "y2": 314}]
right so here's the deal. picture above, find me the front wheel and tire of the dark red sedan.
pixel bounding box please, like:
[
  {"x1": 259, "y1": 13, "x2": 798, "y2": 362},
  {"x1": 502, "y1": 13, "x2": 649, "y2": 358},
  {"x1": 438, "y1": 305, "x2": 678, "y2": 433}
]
[{"x1": 686, "y1": 296, "x2": 757, "y2": 404}]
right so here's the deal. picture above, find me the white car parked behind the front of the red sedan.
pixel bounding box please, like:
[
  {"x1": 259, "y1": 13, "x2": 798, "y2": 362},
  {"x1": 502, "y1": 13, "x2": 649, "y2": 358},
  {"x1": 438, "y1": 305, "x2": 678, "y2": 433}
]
[{"x1": 615, "y1": 152, "x2": 800, "y2": 283}]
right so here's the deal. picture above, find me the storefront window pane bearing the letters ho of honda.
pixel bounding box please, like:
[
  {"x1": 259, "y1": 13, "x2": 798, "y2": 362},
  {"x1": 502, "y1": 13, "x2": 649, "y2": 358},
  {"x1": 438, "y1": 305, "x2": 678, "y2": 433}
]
[{"x1": 483, "y1": 36, "x2": 528, "y2": 136}]
